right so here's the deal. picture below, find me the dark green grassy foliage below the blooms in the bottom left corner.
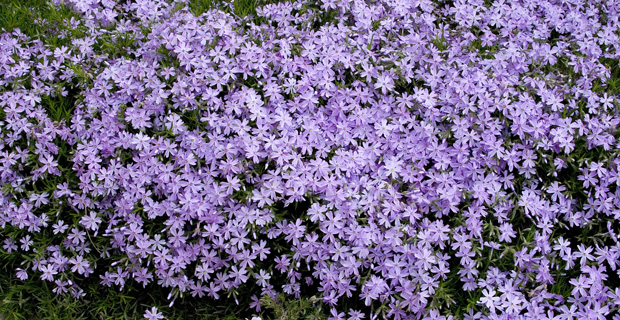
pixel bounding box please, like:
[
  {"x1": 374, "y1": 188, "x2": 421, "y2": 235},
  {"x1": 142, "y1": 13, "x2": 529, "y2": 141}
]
[{"x1": 0, "y1": 269, "x2": 258, "y2": 320}]
